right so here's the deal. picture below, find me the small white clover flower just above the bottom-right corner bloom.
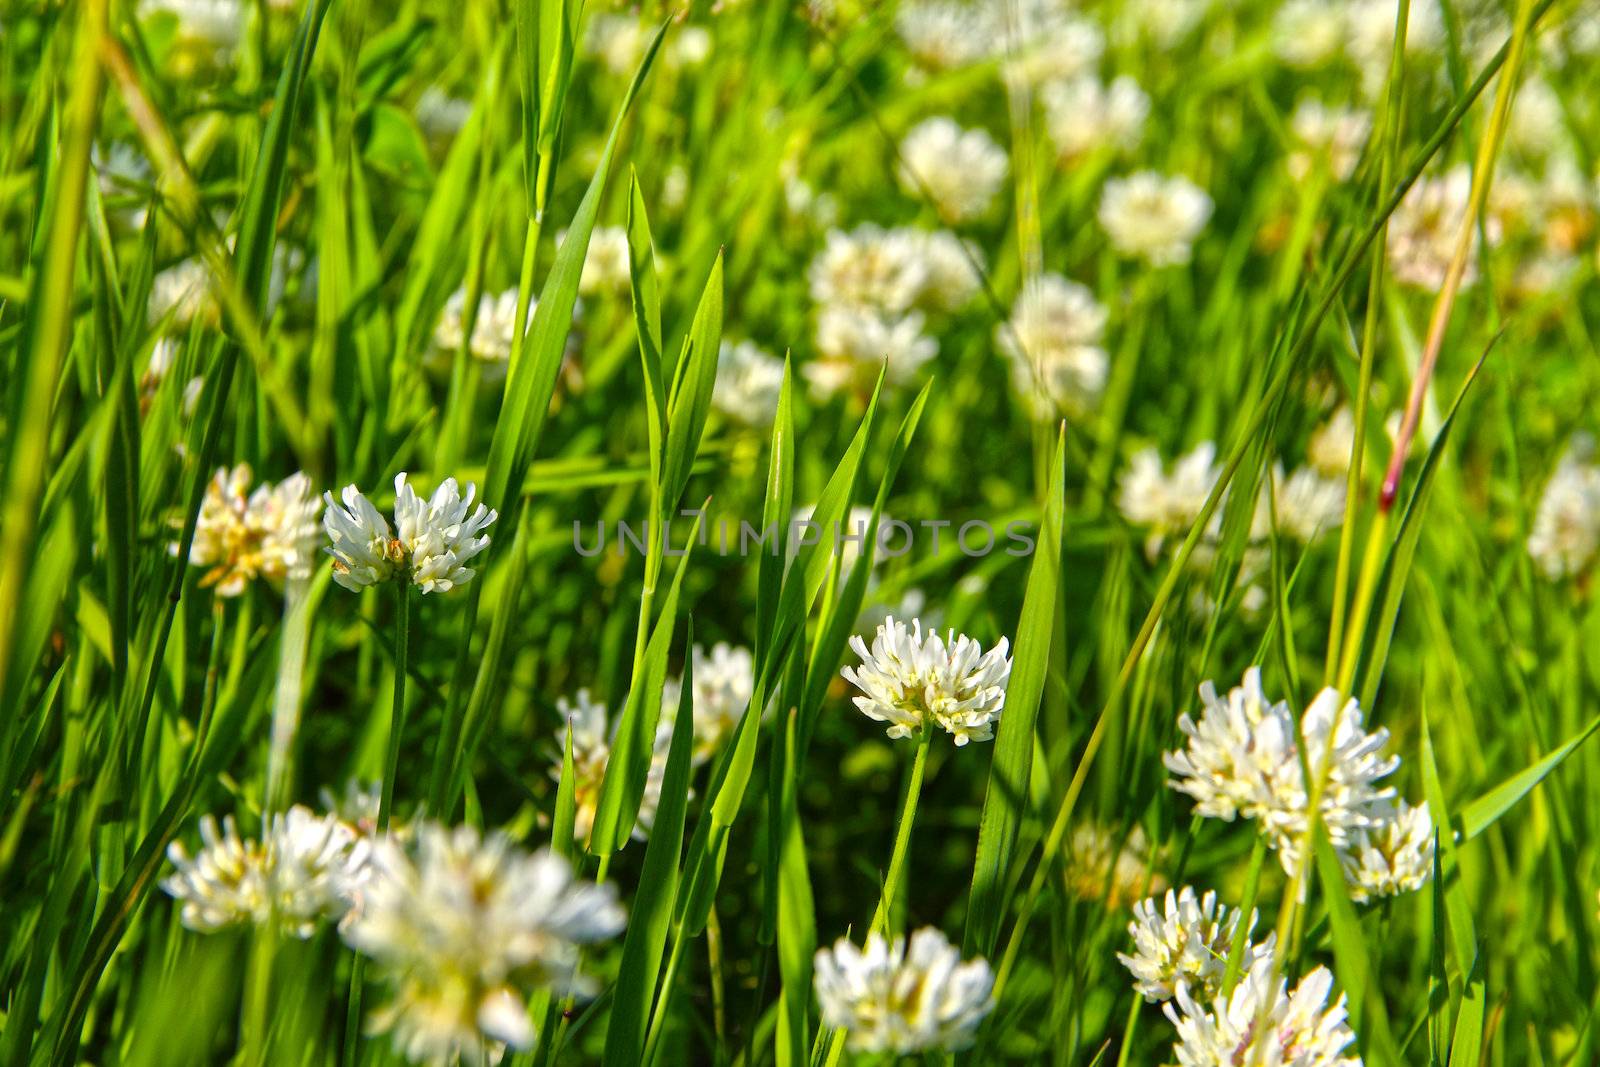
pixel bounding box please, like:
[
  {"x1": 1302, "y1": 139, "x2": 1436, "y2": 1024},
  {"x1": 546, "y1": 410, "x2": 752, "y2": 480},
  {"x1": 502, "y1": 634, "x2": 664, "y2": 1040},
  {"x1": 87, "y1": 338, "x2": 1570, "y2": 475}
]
[{"x1": 1117, "y1": 886, "x2": 1277, "y2": 1005}]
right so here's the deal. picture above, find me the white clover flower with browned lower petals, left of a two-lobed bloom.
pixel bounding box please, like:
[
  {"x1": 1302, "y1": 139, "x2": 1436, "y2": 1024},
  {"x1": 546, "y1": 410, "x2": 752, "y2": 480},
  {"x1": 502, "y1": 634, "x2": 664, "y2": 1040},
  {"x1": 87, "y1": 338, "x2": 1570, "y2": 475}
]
[{"x1": 189, "y1": 464, "x2": 322, "y2": 597}]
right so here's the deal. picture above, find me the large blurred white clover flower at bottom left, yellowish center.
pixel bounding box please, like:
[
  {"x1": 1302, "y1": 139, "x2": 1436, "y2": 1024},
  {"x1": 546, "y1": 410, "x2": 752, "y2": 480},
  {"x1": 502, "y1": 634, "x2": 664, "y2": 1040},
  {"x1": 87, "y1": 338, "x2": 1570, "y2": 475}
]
[{"x1": 341, "y1": 824, "x2": 624, "y2": 1064}]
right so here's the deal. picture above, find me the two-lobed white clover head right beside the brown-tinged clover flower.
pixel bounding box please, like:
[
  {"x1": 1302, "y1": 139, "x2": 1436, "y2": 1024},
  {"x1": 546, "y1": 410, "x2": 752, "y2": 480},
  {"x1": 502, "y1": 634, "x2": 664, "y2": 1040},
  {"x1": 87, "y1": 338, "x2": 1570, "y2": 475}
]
[{"x1": 322, "y1": 472, "x2": 499, "y2": 593}]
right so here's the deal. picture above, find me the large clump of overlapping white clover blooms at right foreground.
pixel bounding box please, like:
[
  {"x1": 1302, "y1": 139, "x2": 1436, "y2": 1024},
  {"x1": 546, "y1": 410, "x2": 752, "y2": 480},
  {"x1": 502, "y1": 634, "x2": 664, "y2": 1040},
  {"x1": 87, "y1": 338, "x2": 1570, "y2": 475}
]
[{"x1": 1162, "y1": 667, "x2": 1432, "y2": 893}]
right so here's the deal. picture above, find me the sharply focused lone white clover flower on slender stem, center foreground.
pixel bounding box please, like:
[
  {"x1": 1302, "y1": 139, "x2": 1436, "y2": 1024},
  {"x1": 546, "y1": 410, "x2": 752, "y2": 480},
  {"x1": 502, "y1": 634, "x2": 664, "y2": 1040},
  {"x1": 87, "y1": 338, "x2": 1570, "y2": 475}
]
[{"x1": 842, "y1": 616, "x2": 1011, "y2": 747}]
